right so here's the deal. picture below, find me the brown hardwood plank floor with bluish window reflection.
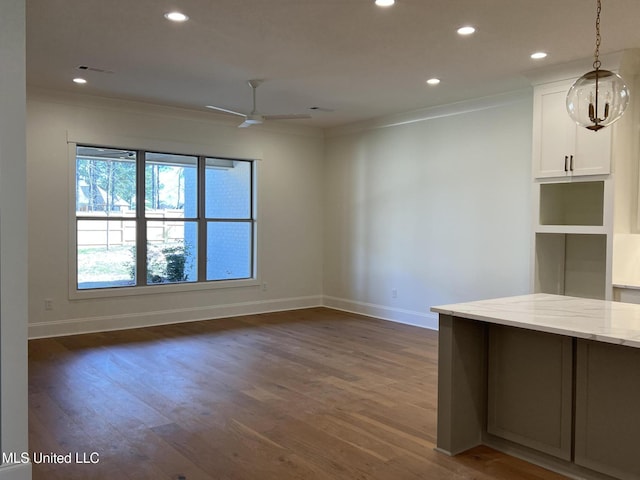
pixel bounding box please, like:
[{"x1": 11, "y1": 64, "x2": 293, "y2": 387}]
[{"x1": 29, "y1": 308, "x2": 564, "y2": 480}]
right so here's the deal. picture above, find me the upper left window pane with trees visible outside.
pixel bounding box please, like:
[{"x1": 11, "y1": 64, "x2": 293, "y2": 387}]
[{"x1": 76, "y1": 146, "x2": 136, "y2": 217}]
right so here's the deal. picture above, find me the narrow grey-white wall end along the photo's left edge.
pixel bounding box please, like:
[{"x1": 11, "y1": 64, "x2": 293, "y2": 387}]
[{"x1": 0, "y1": 0, "x2": 31, "y2": 480}]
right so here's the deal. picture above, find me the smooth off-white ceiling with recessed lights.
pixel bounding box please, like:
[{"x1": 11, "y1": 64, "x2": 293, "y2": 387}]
[{"x1": 27, "y1": 0, "x2": 640, "y2": 127}]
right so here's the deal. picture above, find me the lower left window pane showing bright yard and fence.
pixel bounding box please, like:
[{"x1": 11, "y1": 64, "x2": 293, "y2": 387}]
[{"x1": 77, "y1": 220, "x2": 136, "y2": 290}]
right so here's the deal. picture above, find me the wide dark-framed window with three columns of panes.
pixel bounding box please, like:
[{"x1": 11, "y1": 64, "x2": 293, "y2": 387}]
[{"x1": 75, "y1": 145, "x2": 255, "y2": 290}]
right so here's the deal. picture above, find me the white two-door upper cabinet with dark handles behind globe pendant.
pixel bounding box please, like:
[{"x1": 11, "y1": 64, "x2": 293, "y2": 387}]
[{"x1": 533, "y1": 82, "x2": 611, "y2": 178}]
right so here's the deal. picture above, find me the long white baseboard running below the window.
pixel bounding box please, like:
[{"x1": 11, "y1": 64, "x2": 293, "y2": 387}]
[{"x1": 27, "y1": 295, "x2": 322, "y2": 340}]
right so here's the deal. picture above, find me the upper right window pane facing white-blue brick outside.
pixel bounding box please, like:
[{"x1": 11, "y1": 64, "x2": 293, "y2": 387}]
[{"x1": 205, "y1": 158, "x2": 251, "y2": 219}]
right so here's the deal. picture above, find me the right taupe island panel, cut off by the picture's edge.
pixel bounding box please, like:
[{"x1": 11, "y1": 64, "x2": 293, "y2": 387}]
[{"x1": 575, "y1": 340, "x2": 640, "y2": 480}]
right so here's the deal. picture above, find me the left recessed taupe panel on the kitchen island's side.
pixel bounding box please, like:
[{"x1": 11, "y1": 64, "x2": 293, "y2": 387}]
[{"x1": 487, "y1": 325, "x2": 573, "y2": 460}]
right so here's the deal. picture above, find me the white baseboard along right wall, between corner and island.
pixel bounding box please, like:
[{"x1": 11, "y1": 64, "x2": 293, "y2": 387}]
[{"x1": 322, "y1": 296, "x2": 438, "y2": 330}]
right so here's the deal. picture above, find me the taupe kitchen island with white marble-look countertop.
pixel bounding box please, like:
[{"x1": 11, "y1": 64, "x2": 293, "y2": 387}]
[{"x1": 432, "y1": 294, "x2": 640, "y2": 479}]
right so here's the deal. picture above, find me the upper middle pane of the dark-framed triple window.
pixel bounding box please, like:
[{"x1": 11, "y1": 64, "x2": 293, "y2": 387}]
[{"x1": 145, "y1": 153, "x2": 198, "y2": 218}]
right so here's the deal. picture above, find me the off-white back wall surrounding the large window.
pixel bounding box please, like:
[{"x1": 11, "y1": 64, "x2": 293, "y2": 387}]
[{"x1": 27, "y1": 89, "x2": 323, "y2": 337}]
